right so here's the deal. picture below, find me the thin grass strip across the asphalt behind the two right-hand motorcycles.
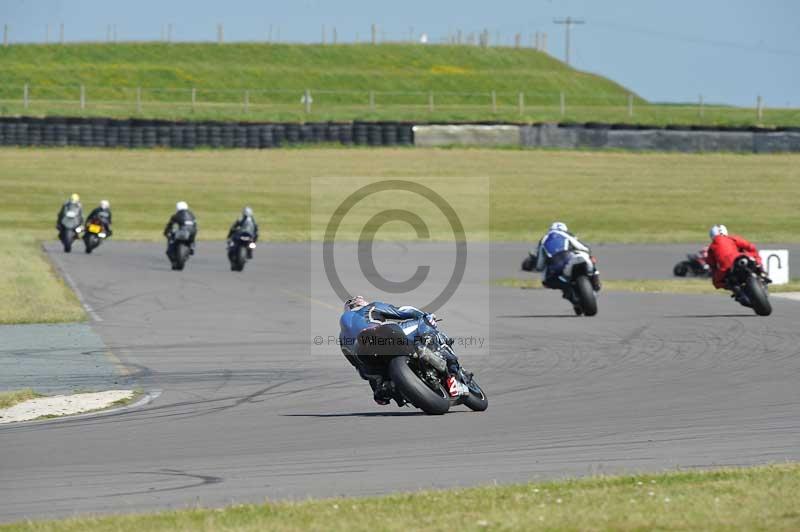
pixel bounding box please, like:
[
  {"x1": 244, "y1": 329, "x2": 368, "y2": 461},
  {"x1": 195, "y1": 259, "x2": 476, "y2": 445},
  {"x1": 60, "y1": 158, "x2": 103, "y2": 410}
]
[{"x1": 494, "y1": 277, "x2": 800, "y2": 295}]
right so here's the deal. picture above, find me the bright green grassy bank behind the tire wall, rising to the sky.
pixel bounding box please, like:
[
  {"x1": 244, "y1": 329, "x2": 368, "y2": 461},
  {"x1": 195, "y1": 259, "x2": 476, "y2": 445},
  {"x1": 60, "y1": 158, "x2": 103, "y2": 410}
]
[{"x1": 0, "y1": 43, "x2": 800, "y2": 126}]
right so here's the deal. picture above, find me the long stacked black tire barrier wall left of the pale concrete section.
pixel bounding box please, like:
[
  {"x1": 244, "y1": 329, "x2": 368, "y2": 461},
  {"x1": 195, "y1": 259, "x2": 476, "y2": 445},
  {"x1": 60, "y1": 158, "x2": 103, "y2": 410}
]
[{"x1": 0, "y1": 117, "x2": 414, "y2": 149}]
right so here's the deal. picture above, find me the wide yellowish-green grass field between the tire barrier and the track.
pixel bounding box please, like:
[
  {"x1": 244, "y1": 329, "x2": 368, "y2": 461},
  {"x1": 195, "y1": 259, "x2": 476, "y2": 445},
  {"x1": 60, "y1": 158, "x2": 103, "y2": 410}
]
[{"x1": 0, "y1": 148, "x2": 800, "y2": 323}]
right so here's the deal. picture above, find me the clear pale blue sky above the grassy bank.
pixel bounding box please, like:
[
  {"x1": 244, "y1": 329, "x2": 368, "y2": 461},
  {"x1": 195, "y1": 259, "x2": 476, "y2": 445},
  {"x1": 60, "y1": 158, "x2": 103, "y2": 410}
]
[{"x1": 0, "y1": 0, "x2": 800, "y2": 107}]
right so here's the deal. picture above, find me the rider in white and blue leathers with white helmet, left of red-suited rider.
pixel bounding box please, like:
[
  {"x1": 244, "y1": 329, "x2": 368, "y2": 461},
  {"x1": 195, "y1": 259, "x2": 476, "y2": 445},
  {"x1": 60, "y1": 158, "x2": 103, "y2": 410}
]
[{"x1": 536, "y1": 222, "x2": 600, "y2": 298}]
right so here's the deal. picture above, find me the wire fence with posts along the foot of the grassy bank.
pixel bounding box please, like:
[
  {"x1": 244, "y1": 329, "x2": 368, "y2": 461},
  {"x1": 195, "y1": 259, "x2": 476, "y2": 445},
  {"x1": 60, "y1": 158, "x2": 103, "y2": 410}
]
[{"x1": 0, "y1": 84, "x2": 800, "y2": 125}]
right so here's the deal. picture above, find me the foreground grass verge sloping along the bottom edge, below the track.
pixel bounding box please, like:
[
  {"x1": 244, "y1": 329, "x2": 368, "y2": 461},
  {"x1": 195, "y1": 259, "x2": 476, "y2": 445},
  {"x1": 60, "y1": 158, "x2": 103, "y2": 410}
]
[{"x1": 0, "y1": 464, "x2": 800, "y2": 532}]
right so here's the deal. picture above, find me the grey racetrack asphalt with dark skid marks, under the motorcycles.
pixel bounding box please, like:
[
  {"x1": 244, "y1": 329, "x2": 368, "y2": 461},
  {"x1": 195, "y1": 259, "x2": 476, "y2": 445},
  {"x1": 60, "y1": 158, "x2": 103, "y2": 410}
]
[{"x1": 0, "y1": 241, "x2": 800, "y2": 521}]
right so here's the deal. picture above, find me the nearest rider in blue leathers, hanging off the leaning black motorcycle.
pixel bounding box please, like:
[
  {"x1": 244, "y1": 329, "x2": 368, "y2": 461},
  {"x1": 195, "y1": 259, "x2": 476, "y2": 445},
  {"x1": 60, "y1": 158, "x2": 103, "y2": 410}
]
[{"x1": 339, "y1": 296, "x2": 476, "y2": 405}]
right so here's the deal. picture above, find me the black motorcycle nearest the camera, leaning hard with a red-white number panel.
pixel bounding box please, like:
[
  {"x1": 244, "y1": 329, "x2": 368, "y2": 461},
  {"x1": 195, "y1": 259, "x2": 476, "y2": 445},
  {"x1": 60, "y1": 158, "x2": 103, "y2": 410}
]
[{"x1": 343, "y1": 317, "x2": 489, "y2": 415}]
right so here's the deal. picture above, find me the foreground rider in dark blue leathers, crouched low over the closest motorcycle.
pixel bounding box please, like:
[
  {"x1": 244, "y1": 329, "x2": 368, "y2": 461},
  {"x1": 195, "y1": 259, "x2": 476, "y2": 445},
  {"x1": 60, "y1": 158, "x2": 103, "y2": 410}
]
[{"x1": 339, "y1": 296, "x2": 469, "y2": 405}]
